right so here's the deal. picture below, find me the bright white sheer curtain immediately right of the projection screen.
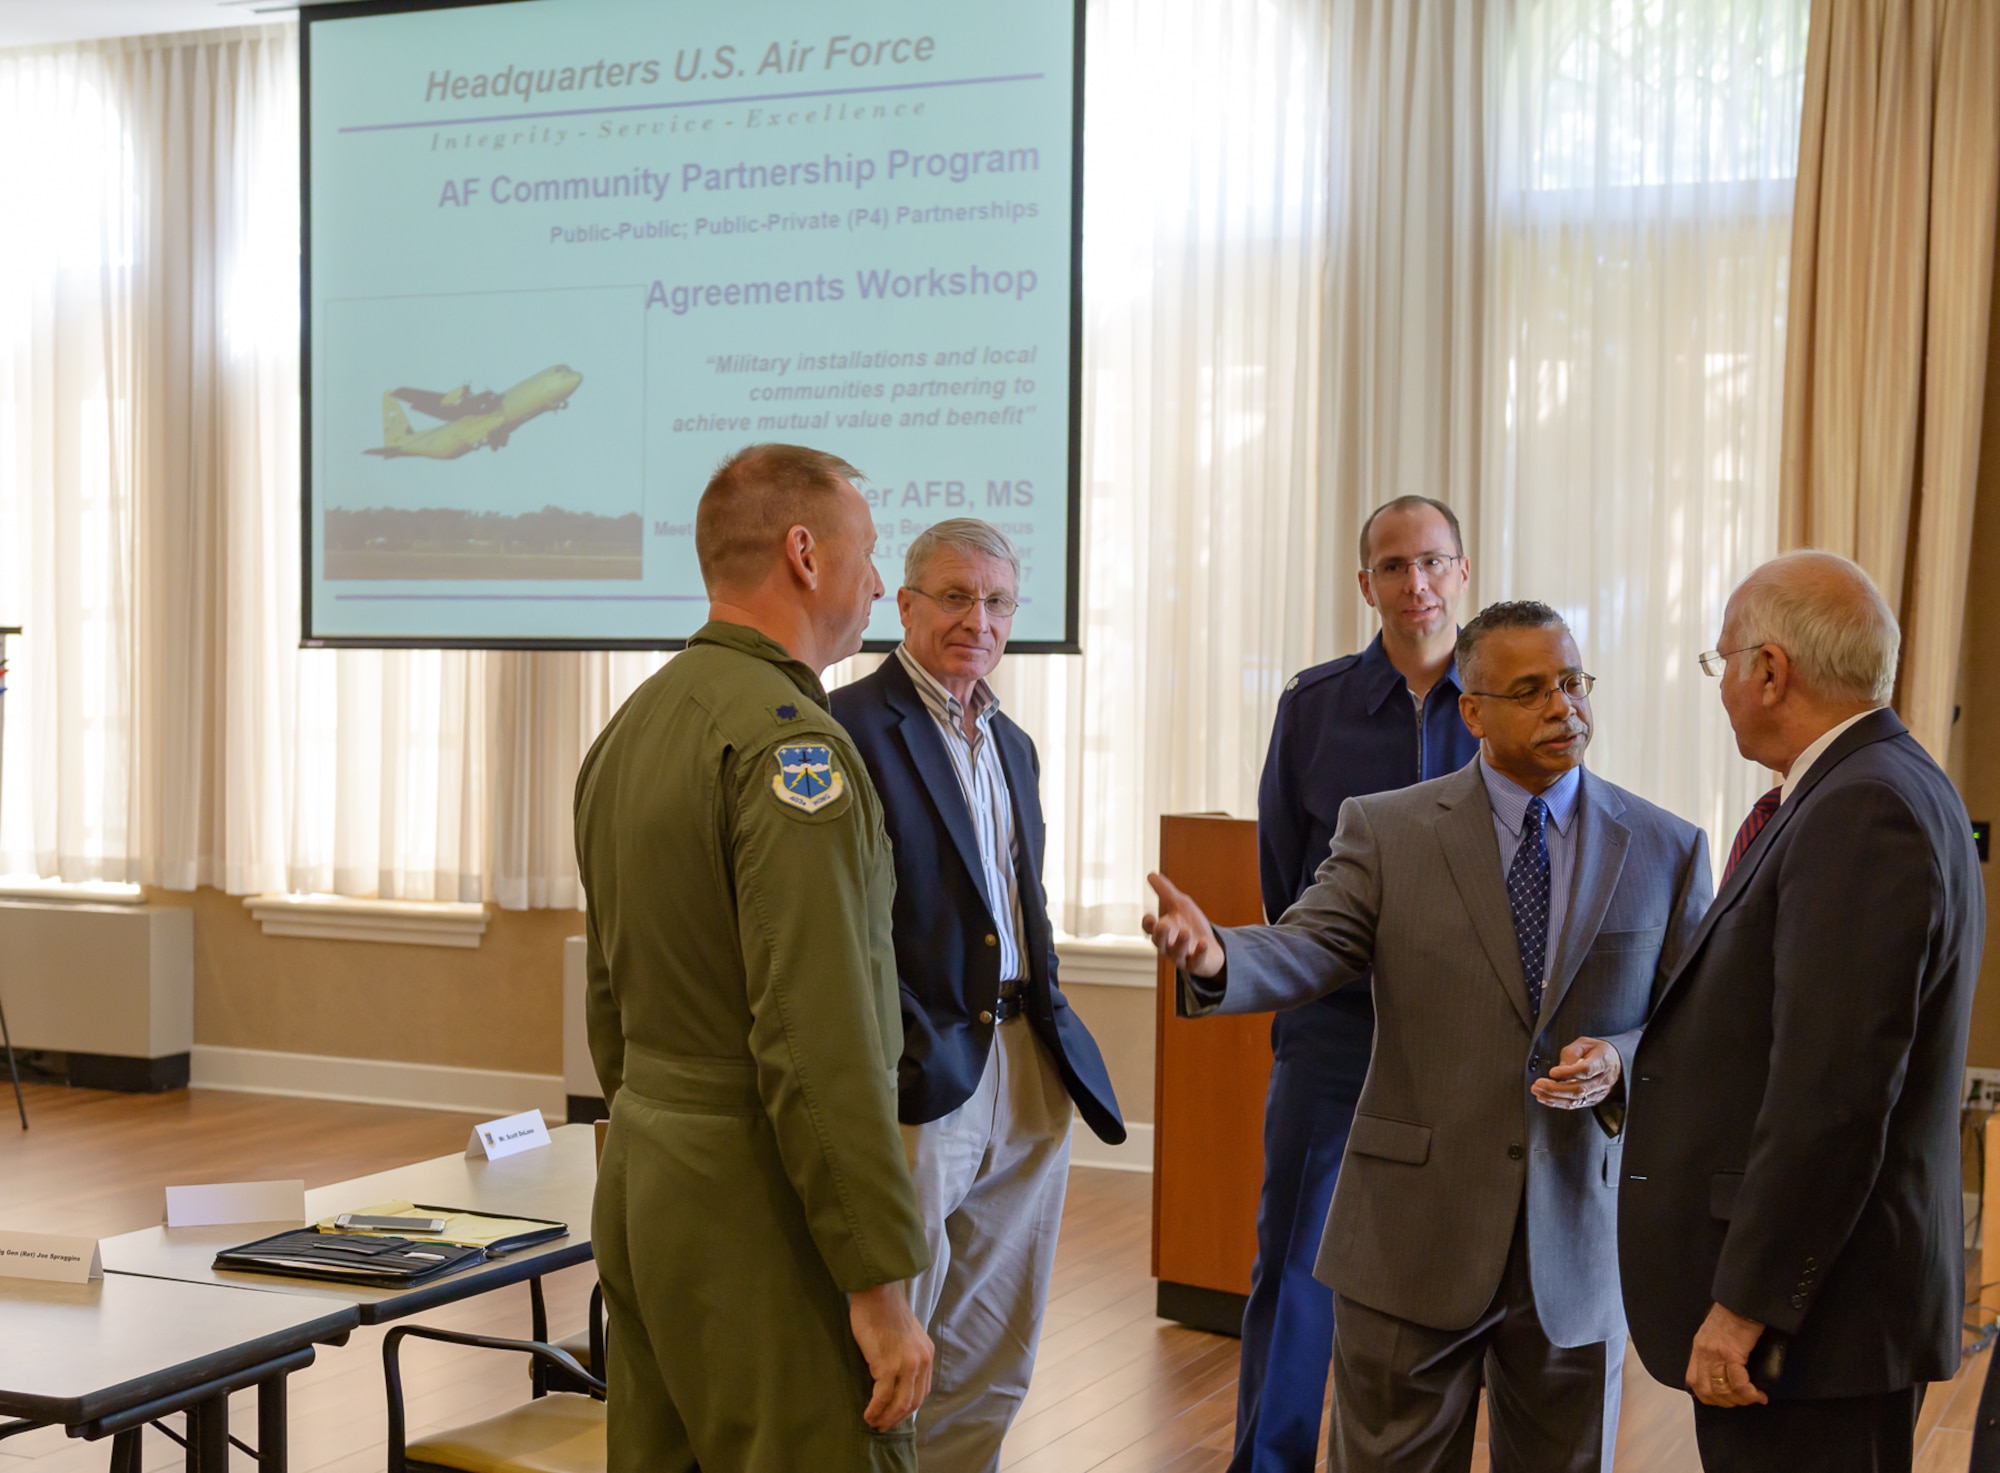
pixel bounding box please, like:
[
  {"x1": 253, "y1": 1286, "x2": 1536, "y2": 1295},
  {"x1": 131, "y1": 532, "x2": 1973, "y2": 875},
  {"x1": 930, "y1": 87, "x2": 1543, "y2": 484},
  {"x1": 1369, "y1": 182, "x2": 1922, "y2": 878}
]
[{"x1": 998, "y1": 0, "x2": 1338, "y2": 935}]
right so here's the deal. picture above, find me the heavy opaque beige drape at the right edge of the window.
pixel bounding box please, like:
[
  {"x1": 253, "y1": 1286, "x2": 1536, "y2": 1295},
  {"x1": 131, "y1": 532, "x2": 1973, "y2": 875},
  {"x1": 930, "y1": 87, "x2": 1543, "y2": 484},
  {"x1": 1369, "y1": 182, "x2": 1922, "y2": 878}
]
[{"x1": 1780, "y1": 0, "x2": 2000, "y2": 761}]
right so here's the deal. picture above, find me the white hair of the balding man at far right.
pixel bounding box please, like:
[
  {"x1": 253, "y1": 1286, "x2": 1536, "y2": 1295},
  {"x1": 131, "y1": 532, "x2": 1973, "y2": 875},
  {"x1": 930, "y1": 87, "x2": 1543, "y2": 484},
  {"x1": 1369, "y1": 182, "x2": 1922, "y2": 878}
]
[{"x1": 1736, "y1": 548, "x2": 1902, "y2": 704}]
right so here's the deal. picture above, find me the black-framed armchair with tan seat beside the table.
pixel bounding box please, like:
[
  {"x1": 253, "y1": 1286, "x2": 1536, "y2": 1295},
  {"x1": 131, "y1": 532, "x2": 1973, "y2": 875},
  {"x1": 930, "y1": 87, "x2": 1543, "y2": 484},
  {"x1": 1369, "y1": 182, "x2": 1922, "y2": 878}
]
[{"x1": 382, "y1": 1325, "x2": 606, "y2": 1473}]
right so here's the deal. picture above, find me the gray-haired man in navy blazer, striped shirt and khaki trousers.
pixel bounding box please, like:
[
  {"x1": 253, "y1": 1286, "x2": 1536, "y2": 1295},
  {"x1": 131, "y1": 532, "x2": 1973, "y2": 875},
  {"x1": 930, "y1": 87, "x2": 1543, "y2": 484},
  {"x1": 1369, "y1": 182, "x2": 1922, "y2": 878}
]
[{"x1": 832, "y1": 518, "x2": 1126, "y2": 1473}]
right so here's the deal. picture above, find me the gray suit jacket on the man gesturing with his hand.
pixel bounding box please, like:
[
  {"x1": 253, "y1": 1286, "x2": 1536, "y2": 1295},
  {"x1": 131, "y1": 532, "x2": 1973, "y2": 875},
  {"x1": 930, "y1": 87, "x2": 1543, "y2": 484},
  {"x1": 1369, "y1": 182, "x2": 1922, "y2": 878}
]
[{"x1": 1180, "y1": 761, "x2": 1710, "y2": 1345}]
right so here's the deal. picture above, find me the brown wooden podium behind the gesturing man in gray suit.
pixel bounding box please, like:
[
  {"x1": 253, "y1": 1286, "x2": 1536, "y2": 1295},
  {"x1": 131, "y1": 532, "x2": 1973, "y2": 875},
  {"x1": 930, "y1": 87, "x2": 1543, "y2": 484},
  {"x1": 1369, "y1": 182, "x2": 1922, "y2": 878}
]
[{"x1": 1152, "y1": 813, "x2": 1270, "y2": 1335}]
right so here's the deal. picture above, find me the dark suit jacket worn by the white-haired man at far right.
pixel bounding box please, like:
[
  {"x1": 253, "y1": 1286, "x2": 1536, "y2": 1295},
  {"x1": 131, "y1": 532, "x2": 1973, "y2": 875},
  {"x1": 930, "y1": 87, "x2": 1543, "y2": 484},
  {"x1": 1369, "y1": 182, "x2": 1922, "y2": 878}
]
[{"x1": 1618, "y1": 710, "x2": 1984, "y2": 1399}]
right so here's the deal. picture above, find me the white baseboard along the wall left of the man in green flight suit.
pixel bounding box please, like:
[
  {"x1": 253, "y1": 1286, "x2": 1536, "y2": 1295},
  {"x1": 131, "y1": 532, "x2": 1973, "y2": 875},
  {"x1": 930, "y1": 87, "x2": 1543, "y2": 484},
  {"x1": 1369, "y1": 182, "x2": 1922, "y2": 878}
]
[{"x1": 188, "y1": 1043, "x2": 568, "y2": 1121}]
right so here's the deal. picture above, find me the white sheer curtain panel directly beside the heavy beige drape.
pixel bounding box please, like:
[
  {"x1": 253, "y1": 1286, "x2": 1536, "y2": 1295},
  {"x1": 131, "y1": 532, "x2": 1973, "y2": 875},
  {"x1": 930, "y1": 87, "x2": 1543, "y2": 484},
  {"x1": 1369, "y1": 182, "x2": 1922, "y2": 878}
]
[{"x1": 1476, "y1": 0, "x2": 1810, "y2": 847}]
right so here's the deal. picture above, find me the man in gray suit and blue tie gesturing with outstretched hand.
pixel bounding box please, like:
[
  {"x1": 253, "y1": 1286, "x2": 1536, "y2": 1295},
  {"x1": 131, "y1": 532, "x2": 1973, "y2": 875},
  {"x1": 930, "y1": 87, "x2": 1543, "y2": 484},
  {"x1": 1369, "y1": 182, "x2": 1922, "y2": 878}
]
[{"x1": 1146, "y1": 602, "x2": 1710, "y2": 1473}]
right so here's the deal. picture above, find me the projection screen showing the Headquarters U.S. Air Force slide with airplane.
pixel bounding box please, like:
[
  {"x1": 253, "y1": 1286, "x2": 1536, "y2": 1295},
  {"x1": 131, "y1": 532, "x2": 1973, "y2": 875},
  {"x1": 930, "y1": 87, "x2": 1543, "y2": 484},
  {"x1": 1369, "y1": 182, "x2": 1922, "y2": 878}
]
[{"x1": 302, "y1": 0, "x2": 1080, "y2": 648}]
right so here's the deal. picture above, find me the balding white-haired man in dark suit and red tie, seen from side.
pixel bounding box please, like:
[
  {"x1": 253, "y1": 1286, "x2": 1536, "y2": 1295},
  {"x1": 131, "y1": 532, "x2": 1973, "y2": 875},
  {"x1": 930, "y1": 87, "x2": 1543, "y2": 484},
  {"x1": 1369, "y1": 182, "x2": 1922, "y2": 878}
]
[{"x1": 1618, "y1": 552, "x2": 1984, "y2": 1473}]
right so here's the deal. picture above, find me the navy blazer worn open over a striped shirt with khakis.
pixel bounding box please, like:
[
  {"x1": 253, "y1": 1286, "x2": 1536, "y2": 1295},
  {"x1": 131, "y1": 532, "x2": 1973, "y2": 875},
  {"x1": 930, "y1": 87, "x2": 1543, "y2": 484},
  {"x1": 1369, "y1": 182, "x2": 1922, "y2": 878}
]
[{"x1": 832, "y1": 656, "x2": 1126, "y2": 1145}]
